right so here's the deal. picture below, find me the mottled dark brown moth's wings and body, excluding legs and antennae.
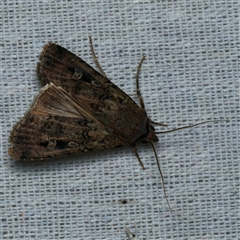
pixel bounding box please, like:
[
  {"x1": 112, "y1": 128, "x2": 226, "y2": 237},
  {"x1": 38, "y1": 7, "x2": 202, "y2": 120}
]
[{"x1": 9, "y1": 43, "x2": 158, "y2": 160}]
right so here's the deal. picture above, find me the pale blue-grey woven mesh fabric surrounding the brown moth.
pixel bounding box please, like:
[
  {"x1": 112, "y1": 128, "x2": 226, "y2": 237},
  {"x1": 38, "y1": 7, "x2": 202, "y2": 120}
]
[{"x1": 0, "y1": 0, "x2": 240, "y2": 240}]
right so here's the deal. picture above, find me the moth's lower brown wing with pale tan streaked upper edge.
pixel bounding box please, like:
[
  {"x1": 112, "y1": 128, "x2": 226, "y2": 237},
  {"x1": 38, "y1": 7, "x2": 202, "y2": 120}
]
[{"x1": 9, "y1": 83, "x2": 127, "y2": 160}]
